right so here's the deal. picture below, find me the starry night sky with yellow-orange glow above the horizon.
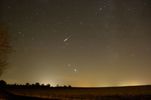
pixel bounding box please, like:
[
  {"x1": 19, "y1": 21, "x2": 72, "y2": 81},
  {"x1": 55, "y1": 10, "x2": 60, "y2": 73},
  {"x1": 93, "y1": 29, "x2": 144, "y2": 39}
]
[{"x1": 0, "y1": 0, "x2": 151, "y2": 87}]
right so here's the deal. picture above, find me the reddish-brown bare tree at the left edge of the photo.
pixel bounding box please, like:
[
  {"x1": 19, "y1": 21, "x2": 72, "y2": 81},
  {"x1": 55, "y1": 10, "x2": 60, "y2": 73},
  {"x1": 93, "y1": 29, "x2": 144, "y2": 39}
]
[{"x1": 0, "y1": 25, "x2": 11, "y2": 76}]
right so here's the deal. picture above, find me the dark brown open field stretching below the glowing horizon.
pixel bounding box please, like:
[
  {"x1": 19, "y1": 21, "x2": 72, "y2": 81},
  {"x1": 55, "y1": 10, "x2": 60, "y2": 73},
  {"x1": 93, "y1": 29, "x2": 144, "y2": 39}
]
[{"x1": 0, "y1": 86, "x2": 151, "y2": 100}]
